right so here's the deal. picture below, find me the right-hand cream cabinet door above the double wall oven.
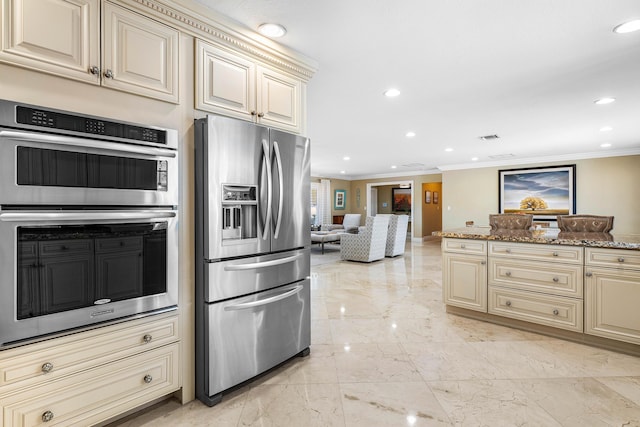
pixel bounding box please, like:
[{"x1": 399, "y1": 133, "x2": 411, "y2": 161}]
[{"x1": 102, "y1": 2, "x2": 179, "y2": 103}]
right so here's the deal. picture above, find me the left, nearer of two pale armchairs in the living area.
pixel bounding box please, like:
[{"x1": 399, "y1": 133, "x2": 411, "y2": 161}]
[{"x1": 340, "y1": 216, "x2": 389, "y2": 262}]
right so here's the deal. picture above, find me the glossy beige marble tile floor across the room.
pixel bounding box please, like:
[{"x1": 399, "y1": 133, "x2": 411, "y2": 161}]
[{"x1": 113, "y1": 241, "x2": 640, "y2": 427}]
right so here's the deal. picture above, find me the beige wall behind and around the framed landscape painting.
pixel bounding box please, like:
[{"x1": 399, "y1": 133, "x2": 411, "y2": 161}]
[{"x1": 442, "y1": 155, "x2": 640, "y2": 234}]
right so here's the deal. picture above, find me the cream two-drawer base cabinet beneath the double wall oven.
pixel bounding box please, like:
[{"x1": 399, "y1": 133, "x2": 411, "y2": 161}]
[{"x1": 0, "y1": 314, "x2": 181, "y2": 427}]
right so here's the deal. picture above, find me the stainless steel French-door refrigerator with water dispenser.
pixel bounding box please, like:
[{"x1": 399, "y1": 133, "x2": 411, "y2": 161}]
[{"x1": 195, "y1": 115, "x2": 311, "y2": 406}]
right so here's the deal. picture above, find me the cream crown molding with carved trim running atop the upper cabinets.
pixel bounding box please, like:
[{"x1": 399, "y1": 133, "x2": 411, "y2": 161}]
[{"x1": 119, "y1": 0, "x2": 318, "y2": 81}]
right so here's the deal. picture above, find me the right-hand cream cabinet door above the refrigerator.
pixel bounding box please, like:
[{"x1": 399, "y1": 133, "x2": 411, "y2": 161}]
[{"x1": 256, "y1": 67, "x2": 302, "y2": 133}]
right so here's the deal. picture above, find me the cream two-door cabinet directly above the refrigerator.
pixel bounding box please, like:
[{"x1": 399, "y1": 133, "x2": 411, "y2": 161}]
[{"x1": 195, "y1": 40, "x2": 304, "y2": 133}]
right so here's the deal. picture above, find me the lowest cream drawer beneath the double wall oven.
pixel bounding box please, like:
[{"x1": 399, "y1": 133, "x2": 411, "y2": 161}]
[{"x1": 0, "y1": 344, "x2": 180, "y2": 427}]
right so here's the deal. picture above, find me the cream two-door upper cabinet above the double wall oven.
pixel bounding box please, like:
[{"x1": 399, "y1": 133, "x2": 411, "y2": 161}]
[{"x1": 0, "y1": 0, "x2": 179, "y2": 103}]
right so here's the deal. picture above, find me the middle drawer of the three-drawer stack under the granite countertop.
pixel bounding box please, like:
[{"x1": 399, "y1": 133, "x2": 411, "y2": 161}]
[{"x1": 489, "y1": 258, "x2": 583, "y2": 298}]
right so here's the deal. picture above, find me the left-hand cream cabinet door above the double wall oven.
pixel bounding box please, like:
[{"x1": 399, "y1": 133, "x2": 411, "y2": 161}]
[{"x1": 0, "y1": 0, "x2": 100, "y2": 84}]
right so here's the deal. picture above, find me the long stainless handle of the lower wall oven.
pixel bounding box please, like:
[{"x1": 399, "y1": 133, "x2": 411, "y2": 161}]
[{"x1": 0, "y1": 211, "x2": 176, "y2": 222}]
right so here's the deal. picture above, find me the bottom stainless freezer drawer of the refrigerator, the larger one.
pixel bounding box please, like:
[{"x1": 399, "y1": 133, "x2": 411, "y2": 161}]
[{"x1": 197, "y1": 279, "x2": 311, "y2": 398}]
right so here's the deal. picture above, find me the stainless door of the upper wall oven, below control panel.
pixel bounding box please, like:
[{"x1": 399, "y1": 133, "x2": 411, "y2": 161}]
[{"x1": 0, "y1": 128, "x2": 178, "y2": 206}]
